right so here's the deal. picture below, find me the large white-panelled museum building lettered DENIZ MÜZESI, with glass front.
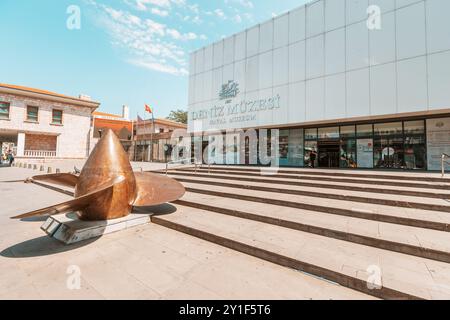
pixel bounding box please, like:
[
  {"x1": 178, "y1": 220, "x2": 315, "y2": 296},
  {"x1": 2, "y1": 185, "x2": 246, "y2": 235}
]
[{"x1": 188, "y1": 0, "x2": 450, "y2": 170}]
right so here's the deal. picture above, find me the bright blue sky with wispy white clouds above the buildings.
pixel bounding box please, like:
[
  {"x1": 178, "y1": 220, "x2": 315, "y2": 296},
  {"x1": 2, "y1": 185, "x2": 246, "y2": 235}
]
[{"x1": 0, "y1": 0, "x2": 307, "y2": 117}]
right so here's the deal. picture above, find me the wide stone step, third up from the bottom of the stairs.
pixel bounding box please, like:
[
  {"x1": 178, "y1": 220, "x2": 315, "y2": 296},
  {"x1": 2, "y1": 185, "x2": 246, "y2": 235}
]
[{"x1": 177, "y1": 183, "x2": 450, "y2": 232}]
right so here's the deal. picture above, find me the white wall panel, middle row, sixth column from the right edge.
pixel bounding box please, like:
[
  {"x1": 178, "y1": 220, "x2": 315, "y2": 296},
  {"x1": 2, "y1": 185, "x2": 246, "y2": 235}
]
[{"x1": 306, "y1": 35, "x2": 325, "y2": 79}]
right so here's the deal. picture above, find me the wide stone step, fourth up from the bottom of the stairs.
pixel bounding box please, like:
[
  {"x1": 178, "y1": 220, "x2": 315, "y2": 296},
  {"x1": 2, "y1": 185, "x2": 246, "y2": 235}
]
[{"x1": 169, "y1": 176, "x2": 450, "y2": 212}]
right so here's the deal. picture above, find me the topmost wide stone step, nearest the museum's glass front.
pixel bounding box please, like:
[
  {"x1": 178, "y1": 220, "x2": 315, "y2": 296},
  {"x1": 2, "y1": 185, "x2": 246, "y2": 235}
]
[{"x1": 192, "y1": 165, "x2": 450, "y2": 183}]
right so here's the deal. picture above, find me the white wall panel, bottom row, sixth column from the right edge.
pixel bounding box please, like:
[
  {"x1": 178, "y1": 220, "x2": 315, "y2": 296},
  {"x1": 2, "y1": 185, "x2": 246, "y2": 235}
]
[{"x1": 306, "y1": 78, "x2": 325, "y2": 121}]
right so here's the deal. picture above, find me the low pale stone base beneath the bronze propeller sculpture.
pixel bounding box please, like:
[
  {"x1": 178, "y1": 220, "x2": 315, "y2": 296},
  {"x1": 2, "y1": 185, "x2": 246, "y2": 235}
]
[{"x1": 41, "y1": 213, "x2": 151, "y2": 244}]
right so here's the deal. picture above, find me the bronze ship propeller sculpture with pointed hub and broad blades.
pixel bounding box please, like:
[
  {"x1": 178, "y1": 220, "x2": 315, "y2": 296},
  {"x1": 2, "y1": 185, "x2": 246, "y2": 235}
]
[{"x1": 13, "y1": 130, "x2": 185, "y2": 221}]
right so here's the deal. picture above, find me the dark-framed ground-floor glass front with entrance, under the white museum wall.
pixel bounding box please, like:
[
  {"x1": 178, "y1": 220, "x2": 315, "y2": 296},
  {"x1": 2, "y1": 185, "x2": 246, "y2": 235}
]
[{"x1": 280, "y1": 120, "x2": 427, "y2": 170}]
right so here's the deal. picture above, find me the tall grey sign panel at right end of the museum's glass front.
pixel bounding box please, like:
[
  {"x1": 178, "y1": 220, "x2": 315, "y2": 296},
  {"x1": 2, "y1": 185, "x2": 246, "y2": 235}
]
[{"x1": 427, "y1": 118, "x2": 450, "y2": 170}]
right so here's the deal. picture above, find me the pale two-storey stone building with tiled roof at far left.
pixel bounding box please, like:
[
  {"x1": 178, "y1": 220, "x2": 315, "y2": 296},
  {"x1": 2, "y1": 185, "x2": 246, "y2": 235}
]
[{"x1": 0, "y1": 84, "x2": 99, "y2": 159}]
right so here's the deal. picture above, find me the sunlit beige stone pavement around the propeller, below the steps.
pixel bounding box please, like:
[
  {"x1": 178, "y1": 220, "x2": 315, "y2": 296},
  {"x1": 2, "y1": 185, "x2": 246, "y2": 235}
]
[{"x1": 0, "y1": 167, "x2": 373, "y2": 299}]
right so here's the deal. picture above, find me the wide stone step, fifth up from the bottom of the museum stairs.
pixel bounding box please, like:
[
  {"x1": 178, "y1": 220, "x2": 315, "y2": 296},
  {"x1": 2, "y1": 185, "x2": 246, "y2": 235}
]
[{"x1": 170, "y1": 171, "x2": 450, "y2": 199}]
